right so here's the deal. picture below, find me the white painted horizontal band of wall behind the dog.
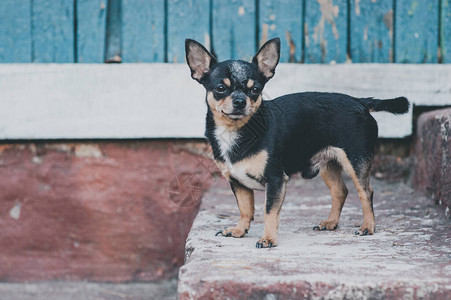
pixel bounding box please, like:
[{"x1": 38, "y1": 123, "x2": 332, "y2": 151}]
[{"x1": 0, "y1": 64, "x2": 451, "y2": 139}]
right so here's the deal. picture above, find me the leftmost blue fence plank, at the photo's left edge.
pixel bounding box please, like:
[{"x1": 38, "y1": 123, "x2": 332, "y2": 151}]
[{"x1": 0, "y1": 0, "x2": 31, "y2": 63}]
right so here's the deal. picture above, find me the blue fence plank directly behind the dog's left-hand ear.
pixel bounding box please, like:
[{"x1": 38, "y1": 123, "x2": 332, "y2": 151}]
[{"x1": 167, "y1": 0, "x2": 211, "y2": 62}]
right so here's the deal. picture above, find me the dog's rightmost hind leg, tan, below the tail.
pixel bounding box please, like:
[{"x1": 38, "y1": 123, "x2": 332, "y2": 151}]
[{"x1": 337, "y1": 148, "x2": 376, "y2": 235}]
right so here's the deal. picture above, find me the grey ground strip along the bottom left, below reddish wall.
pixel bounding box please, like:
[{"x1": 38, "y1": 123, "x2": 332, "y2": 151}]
[{"x1": 0, "y1": 279, "x2": 177, "y2": 300}]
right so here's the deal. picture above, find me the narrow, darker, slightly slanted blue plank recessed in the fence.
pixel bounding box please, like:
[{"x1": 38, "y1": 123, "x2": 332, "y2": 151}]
[{"x1": 104, "y1": 0, "x2": 122, "y2": 62}]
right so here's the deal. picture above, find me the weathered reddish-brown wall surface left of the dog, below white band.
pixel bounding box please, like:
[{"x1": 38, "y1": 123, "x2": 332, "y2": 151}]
[{"x1": 0, "y1": 141, "x2": 214, "y2": 282}]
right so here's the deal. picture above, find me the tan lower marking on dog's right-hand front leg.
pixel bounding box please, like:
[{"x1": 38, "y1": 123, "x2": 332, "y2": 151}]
[{"x1": 257, "y1": 180, "x2": 287, "y2": 248}]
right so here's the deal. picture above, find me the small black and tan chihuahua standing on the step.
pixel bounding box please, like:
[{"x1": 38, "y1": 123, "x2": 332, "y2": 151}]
[{"x1": 185, "y1": 38, "x2": 409, "y2": 248}]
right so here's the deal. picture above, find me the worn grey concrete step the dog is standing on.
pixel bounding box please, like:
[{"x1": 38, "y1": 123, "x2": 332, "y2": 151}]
[{"x1": 178, "y1": 178, "x2": 451, "y2": 299}]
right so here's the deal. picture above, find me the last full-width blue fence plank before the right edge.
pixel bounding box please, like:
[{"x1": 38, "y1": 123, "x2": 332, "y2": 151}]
[{"x1": 395, "y1": 0, "x2": 439, "y2": 63}]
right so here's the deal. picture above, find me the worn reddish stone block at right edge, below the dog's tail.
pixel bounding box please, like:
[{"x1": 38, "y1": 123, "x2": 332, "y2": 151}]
[{"x1": 413, "y1": 108, "x2": 451, "y2": 216}]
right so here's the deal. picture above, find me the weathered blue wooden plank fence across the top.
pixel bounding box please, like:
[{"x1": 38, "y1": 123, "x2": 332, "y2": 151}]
[{"x1": 0, "y1": 0, "x2": 451, "y2": 63}]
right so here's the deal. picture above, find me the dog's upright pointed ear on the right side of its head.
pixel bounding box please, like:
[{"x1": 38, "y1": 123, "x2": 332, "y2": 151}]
[{"x1": 252, "y1": 38, "x2": 280, "y2": 80}]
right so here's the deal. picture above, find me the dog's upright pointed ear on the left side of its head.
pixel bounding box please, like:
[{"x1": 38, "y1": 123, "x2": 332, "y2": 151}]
[{"x1": 185, "y1": 39, "x2": 216, "y2": 83}]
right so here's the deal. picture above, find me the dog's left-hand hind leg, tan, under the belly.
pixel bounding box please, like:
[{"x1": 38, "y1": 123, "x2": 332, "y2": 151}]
[{"x1": 313, "y1": 160, "x2": 348, "y2": 230}]
